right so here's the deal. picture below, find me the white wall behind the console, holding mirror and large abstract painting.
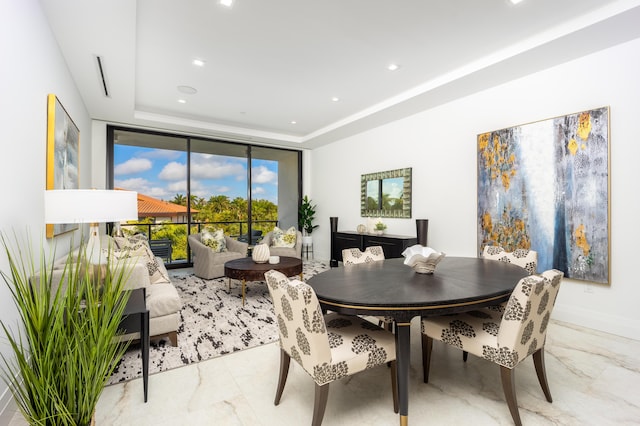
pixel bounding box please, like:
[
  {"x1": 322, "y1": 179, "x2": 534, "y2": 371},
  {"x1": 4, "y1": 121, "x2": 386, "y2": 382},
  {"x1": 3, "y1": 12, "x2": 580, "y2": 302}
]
[{"x1": 312, "y1": 39, "x2": 640, "y2": 339}]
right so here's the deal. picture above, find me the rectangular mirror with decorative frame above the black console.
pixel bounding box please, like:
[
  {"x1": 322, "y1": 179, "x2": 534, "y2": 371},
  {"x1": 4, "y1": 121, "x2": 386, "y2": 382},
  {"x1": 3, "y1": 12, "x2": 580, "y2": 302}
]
[{"x1": 360, "y1": 167, "x2": 411, "y2": 218}]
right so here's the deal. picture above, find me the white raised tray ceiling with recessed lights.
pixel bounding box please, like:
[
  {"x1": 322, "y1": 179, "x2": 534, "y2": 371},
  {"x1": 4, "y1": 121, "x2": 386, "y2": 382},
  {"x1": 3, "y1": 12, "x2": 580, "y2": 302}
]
[{"x1": 41, "y1": 0, "x2": 640, "y2": 148}]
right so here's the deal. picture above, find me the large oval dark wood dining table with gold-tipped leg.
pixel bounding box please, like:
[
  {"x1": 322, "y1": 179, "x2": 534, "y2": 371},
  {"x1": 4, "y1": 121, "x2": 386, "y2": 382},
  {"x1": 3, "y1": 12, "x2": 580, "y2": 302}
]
[{"x1": 307, "y1": 256, "x2": 528, "y2": 426}]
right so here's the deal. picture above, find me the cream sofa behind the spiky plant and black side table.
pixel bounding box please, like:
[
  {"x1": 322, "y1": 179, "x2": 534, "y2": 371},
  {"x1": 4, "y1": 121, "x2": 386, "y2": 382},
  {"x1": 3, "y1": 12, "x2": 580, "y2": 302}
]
[{"x1": 47, "y1": 237, "x2": 182, "y2": 346}]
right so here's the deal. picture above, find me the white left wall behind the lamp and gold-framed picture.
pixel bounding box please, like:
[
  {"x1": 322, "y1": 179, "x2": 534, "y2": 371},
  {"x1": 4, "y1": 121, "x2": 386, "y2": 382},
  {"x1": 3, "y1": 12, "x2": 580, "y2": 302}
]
[{"x1": 0, "y1": 0, "x2": 91, "y2": 424}]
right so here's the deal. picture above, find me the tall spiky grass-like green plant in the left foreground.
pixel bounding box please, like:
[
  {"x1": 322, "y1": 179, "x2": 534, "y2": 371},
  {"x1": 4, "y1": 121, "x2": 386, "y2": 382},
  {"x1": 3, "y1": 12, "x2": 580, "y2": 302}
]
[{"x1": 0, "y1": 235, "x2": 130, "y2": 426}]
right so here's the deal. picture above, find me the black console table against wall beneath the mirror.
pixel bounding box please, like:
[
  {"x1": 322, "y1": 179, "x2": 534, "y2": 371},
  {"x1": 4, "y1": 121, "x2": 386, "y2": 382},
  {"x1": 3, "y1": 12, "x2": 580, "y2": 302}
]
[{"x1": 331, "y1": 231, "x2": 418, "y2": 261}]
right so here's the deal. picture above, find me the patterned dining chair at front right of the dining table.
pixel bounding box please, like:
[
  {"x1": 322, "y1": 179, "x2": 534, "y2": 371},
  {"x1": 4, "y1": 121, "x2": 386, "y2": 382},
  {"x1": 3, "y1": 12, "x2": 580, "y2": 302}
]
[{"x1": 422, "y1": 269, "x2": 564, "y2": 425}]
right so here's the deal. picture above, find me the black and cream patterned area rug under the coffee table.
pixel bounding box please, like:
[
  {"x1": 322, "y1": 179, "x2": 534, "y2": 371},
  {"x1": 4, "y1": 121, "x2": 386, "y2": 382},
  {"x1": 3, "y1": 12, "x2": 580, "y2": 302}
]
[{"x1": 109, "y1": 260, "x2": 329, "y2": 384}]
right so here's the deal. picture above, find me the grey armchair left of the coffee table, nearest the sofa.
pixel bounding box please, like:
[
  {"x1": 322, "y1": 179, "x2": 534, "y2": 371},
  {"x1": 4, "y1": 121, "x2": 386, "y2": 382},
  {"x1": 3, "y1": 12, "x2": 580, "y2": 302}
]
[{"x1": 188, "y1": 234, "x2": 249, "y2": 280}]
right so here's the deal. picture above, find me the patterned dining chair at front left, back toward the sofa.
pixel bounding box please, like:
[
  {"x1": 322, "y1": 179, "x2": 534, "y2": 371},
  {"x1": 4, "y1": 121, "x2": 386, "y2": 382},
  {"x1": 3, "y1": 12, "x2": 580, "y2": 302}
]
[{"x1": 265, "y1": 270, "x2": 398, "y2": 426}]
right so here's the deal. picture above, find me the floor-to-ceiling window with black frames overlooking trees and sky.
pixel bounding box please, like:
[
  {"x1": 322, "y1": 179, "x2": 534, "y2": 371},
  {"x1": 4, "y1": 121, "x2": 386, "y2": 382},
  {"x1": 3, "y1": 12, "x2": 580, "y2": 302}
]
[{"x1": 107, "y1": 126, "x2": 301, "y2": 266}]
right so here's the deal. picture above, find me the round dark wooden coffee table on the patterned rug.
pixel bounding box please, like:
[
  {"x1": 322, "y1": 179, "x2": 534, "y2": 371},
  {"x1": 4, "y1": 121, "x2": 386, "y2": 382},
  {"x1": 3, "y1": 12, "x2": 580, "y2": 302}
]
[{"x1": 224, "y1": 256, "x2": 302, "y2": 306}]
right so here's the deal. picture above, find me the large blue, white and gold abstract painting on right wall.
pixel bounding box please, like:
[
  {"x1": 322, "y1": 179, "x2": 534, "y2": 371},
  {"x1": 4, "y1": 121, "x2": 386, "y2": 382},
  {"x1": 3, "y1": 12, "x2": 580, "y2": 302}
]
[{"x1": 478, "y1": 107, "x2": 610, "y2": 283}]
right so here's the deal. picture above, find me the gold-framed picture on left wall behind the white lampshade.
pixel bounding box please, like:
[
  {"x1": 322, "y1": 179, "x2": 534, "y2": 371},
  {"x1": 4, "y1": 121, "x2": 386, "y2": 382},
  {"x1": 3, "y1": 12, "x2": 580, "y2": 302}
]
[{"x1": 47, "y1": 94, "x2": 80, "y2": 238}]
